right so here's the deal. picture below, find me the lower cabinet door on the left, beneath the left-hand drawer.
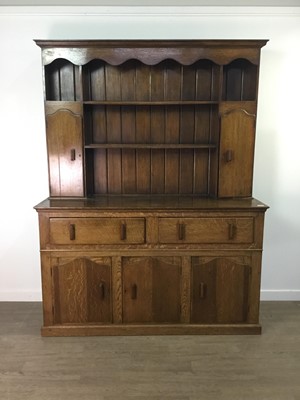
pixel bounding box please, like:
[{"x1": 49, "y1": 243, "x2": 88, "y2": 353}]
[{"x1": 51, "y1": 257, "x2": 112, "y2": 324}]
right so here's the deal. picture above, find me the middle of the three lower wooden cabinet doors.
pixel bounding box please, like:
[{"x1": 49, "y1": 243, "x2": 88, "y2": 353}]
[{"x1": 122, "y1": 257, "x2": 181, "y2": 323}]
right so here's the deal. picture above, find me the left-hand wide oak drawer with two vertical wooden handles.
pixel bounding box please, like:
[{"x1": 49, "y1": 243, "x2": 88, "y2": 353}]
[{"x1": 50, "y1": 218, "x2": 145, "y2": 245}]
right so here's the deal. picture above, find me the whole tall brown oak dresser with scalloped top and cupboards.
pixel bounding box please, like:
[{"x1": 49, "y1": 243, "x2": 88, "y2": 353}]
[{"x1": 35, "y1": 40, "x2": 267, "y2": 336}]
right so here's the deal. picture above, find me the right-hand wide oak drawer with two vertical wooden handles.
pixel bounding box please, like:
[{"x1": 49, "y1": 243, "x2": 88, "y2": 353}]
[{"x1": 158, "y1": 217, "x2": 254, "y2": 243}]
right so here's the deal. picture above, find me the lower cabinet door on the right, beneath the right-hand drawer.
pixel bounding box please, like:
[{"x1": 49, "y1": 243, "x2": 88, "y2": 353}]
[{"x1": 191, "y1": 257, "x2": 251, "y2": 324}]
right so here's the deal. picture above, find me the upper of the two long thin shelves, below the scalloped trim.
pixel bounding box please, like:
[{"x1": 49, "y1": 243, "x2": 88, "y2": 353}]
[{"x1": 83, "y1": 100, "x2": 219, "y2": 106}]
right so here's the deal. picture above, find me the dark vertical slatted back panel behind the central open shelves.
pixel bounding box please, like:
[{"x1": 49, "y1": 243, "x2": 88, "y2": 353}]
[{"x1": 83, "y1": 60, "x2": 220, "y2": 195}]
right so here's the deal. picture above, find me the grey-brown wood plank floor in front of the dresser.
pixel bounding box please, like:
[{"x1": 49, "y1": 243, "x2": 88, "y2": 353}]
[{"x1": 0, "y1": 302, "x2": 300, "y2": 400}]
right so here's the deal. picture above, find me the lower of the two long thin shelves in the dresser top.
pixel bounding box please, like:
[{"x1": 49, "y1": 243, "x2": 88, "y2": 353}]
[{"x1": 84, "y1": 143, "x2": 217, "y2": 150}]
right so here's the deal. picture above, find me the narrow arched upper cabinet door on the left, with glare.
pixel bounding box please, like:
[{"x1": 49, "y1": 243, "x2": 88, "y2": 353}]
[{"x1": 46, "y1": 104, "x2": 84, "y2": 197}]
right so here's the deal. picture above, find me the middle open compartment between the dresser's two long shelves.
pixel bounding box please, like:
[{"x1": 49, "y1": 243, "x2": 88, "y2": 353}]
[{"x1": 83, "y1": 104, "x2": 219, "y2": 149}]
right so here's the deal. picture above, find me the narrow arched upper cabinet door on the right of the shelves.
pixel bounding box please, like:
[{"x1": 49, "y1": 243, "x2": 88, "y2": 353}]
[{"x1": 218, "y1": 103, "x2": 255, "y2": 197}]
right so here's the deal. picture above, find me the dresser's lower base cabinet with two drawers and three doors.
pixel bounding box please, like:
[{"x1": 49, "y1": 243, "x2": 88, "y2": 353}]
[{"x1": 36, "y1": 198, "x2": 266, "y2": 336}]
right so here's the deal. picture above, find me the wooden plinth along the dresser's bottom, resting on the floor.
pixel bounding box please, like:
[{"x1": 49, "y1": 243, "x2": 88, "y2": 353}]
[{"x1": 41, "y1": 324, "x2": 261, "y2": 336}]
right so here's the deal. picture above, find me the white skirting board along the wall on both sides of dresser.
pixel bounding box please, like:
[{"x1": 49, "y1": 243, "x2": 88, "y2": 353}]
[{"x1": 0, "y1": 290, "x2": 300, "y2": 301}]
